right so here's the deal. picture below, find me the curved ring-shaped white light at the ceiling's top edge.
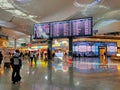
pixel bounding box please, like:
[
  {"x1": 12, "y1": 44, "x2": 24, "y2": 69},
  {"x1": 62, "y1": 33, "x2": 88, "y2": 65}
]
[{"x1": 73, "y1": 0, "x2": 101, "y2": 7}]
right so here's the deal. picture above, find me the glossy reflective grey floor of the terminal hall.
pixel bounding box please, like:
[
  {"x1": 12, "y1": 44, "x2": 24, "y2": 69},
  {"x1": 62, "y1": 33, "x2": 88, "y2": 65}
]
[{"x1": 0, "y1": 58, "x2": 120, "y2": 90}]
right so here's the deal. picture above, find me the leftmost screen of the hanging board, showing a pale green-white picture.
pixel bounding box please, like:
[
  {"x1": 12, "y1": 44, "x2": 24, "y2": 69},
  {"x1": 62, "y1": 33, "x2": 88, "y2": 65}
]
[{"x1": 33, "y1": 23, "x2": 50, "y2": 39}]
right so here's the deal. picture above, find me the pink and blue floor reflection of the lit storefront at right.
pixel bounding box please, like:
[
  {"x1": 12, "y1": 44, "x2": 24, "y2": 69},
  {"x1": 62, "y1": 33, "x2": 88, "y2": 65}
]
[{"x1": 73, "y1": 58, "x2": 118, "y2": 73}]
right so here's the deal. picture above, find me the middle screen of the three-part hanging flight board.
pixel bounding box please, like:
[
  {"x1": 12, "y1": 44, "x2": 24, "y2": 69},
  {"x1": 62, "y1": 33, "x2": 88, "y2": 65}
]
[{"x1": 50, "y1": 21, "x2": 71, "y2": 38}]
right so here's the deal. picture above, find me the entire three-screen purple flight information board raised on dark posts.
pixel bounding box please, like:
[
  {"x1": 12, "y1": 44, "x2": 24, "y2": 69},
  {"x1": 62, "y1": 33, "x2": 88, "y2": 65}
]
[{"x1": 33, "y1": 17, "x2": 92, "y2": 39}]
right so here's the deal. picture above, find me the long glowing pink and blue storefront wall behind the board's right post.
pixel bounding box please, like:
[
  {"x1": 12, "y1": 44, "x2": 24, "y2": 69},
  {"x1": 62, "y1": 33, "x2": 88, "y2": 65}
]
[{"x1": 73, "y1": 41, "x2": 117, "y2": 56}]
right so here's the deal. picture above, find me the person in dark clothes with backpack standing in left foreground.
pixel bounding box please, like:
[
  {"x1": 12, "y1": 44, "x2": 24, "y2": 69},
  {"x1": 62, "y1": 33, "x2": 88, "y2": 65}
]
[{"x1": 10, "y1": 50, "x2": 22, "y2": 84}]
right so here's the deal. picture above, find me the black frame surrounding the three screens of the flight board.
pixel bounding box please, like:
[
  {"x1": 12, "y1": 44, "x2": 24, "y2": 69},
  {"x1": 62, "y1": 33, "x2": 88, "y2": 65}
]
[{"x1": 33, "y1": 17, "x2": 93, "y2": 39}]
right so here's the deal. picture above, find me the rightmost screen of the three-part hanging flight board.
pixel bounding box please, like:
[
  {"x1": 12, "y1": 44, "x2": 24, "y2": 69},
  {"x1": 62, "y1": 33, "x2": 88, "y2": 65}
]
[{"x1": 70, "y1": 18, "x2": 92, "y2": 36}]
